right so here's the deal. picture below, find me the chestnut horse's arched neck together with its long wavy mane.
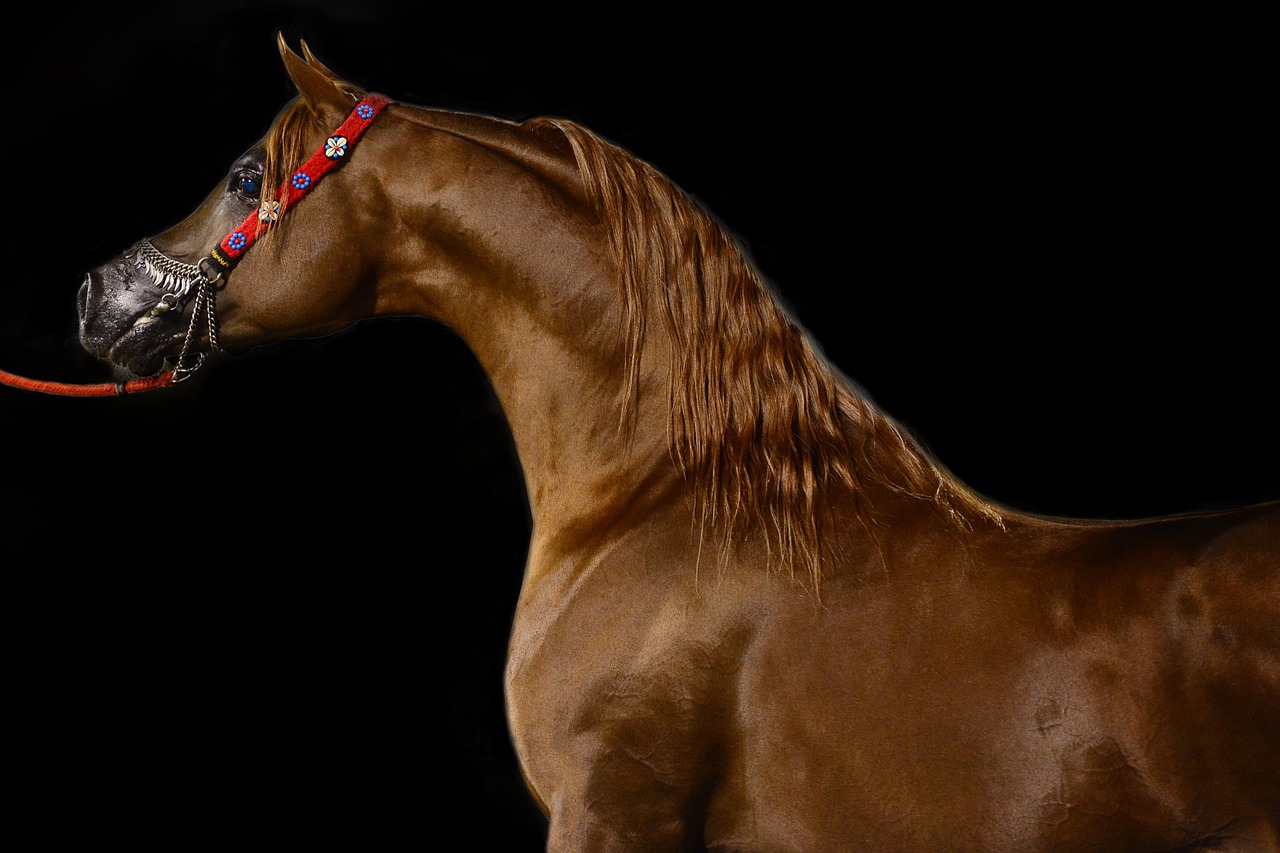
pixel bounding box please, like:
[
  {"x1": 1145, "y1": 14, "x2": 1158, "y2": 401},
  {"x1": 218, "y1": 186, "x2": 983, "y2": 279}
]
[{"x1": 370, "y1": 104, "x2": 989, "y2": 583}]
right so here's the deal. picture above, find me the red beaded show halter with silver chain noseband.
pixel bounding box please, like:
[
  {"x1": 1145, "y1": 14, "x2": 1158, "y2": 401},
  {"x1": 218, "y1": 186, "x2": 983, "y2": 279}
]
[{"x1": 133, "y1": 95, "x2": 390, "y2": 382}]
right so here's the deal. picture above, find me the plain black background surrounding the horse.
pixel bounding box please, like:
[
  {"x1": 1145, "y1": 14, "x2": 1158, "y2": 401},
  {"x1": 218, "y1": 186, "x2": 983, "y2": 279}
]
[{"x1": 0, "y1": 1, "x2": 1280, "y2": 850}]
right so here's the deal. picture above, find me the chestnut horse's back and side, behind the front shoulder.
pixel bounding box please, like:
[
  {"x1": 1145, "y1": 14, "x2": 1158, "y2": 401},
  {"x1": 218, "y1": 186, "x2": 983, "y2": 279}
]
[{"x1": 712, "y1": 494, "x2": 1280, "y2": 850}]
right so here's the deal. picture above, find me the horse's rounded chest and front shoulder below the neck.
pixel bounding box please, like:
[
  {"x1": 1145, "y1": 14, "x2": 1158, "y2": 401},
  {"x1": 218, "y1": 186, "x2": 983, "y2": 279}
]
[{"x1": 507, "y1": 523, "x2": 736, "y2": 850}]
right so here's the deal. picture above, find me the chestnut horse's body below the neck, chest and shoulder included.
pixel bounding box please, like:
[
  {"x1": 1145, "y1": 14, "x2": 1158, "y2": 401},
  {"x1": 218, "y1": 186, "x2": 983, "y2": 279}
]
[{"x1": 508, "y1": 473, "x2": 1280, "y2": 850}]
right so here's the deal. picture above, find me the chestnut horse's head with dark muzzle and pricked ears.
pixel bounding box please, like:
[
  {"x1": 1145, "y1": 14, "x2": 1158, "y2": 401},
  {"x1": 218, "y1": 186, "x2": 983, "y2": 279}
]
[{"x1": 78, "y1": 38, "x2": 391, "y2": 375}]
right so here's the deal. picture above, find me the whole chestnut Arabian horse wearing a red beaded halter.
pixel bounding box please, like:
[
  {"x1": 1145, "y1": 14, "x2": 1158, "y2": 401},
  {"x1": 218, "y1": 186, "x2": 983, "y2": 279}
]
[{"x1": 78, "y1": 37, "x2": 1280, "y2": 853}]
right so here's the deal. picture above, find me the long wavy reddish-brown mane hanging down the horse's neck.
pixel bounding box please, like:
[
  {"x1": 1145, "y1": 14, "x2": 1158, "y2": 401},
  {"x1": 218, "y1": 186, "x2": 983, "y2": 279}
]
[{"x1": 529, "y1": 118, "x2": 1000, "y2": 590}]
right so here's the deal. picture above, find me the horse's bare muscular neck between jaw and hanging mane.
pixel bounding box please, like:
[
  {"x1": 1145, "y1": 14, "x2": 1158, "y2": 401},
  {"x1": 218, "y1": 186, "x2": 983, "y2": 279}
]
[{"x1": 380, "y1": 113, "x2": 678, "y2": 563}]
